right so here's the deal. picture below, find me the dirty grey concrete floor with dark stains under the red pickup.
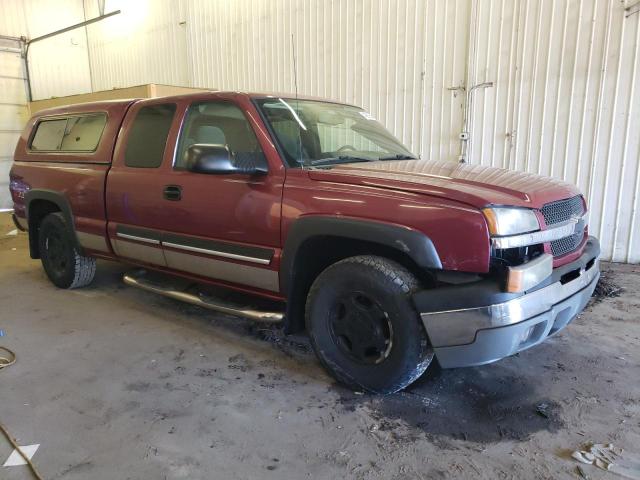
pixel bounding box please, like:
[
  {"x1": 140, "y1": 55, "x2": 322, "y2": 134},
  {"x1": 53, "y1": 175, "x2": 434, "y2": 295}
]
[{"x1": 0, "y1": 215, "x2": 640, "y2": 480}]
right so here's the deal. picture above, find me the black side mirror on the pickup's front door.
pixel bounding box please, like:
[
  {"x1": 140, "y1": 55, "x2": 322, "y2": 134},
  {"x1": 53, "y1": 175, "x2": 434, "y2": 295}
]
[{"x1": 186, "y1": 143, "x2": 269, "y2": 175}]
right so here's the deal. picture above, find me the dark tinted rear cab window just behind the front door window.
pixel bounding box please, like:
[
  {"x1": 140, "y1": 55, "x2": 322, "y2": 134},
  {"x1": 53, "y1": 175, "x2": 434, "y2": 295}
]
[{"x1": 124, "y1": 103, "x2": 176, "y2": 168}]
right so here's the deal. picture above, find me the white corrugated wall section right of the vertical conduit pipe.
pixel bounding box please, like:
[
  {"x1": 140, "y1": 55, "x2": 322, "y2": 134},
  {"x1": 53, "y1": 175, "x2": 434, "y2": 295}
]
[{"x1": 470, "y1": 0, "x2": 640, "y2": 263}]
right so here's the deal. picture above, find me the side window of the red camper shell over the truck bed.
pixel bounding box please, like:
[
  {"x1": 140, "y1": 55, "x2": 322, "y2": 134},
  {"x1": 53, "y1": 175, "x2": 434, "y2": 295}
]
[{"x1": 29, "y1": 113, "x2": 107, "y2": 153}]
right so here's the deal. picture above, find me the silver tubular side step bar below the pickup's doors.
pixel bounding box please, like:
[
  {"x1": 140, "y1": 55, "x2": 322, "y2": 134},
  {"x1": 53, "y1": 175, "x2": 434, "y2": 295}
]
[{"x1": 122, "y1": 274, "x2": 284, "y2": 323}]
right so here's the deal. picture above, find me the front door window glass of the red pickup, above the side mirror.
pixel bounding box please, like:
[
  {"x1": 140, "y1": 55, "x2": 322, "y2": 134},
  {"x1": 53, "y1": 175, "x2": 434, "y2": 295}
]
[{"x1": 173, "y1": 102, "x2": 263, "y2": 169}]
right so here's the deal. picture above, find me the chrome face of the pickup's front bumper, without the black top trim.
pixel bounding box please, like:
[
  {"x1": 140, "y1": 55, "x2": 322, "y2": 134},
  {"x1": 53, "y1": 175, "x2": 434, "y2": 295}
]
[{"x1": 420, "y1": 239, "x2": 600, "y2": 368}]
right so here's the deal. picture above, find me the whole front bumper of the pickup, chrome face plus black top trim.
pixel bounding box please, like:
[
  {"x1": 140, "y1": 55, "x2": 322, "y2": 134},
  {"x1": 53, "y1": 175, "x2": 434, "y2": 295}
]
[{"x1": 413, "y1": 237, "x2": 600, "y2": 368}]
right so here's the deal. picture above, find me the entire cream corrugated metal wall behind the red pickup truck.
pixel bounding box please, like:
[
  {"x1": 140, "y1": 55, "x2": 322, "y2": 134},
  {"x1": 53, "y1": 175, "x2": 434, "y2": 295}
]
[{"x1": 5, "y1": 0, "x2": 640, "y2": 262}]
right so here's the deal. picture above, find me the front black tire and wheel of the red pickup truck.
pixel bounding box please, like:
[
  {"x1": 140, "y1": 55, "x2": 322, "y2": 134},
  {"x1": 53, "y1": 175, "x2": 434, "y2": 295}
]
[{"x1": 305, "y1": 256, "x2": 433, "y2": 393}]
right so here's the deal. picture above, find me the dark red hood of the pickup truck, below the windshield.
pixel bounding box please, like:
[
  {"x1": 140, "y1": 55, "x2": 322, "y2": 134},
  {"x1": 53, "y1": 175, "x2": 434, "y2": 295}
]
[{"x1": 309, "y1": 160, "x2": 580, "y2": 208}]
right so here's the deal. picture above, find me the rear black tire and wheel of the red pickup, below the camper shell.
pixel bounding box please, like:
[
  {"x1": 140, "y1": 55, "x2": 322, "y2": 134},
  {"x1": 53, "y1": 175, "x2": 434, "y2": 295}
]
[{"x1": 38, "y1": 213, "x2": 96, "y2": 288}]
